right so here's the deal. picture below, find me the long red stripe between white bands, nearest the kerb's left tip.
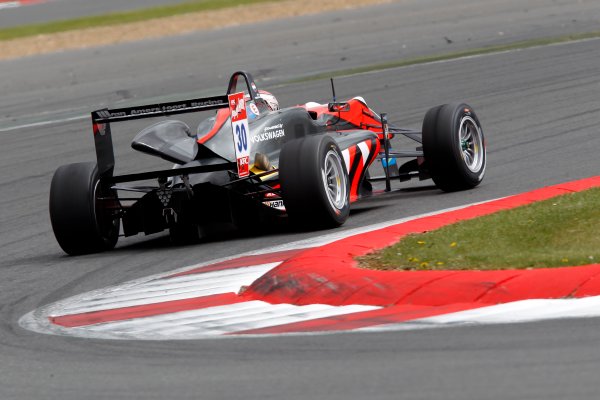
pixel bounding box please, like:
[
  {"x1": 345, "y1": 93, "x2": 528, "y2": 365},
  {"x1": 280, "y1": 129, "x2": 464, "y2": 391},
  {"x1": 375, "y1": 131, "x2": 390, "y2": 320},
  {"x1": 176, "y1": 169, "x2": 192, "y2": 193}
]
[{"x1": 48, "y1": 293, "x2": 245, "y2": 328}]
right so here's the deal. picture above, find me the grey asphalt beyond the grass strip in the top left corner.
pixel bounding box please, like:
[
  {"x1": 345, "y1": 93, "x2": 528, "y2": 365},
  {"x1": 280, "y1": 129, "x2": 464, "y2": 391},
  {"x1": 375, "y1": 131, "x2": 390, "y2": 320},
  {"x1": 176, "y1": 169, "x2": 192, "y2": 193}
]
[{"x1": 0, "y1": 0, "x2": 190, "y2": 28}]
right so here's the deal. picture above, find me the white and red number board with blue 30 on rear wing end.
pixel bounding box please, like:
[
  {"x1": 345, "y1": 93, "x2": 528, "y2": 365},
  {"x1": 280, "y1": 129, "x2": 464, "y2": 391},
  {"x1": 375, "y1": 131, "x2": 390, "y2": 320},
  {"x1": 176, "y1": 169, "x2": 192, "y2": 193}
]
[{"x1": 228, "y1": 93, "x2": 250, "y2": 177}]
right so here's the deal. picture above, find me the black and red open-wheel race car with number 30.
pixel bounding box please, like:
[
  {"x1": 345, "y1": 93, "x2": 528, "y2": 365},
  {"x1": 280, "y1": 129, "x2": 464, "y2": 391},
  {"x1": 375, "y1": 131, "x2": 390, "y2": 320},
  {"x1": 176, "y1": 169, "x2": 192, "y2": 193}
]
[{"x1": 49, "y1": 71, "x2": 486, "y2": 255}]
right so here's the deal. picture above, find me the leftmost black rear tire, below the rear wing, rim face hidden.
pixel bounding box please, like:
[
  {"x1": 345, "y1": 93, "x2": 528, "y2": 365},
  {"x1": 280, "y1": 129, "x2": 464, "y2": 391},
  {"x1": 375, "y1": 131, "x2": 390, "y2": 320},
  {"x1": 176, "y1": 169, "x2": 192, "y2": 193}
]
[{"x1": 50, "y1": 163, "x2": 119, "y2": 255}]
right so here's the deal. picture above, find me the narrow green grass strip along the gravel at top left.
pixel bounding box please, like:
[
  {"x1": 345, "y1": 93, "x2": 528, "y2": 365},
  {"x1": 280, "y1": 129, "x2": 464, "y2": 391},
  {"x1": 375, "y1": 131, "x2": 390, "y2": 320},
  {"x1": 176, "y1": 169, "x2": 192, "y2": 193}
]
[{"x1": 0, "y1": 0, "x2": 277, "y2": 40}]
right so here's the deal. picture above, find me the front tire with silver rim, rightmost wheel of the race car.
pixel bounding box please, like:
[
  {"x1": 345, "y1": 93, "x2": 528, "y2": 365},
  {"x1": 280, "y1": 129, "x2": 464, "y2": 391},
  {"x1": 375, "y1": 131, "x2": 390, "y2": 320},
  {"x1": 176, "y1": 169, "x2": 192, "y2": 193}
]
[{"x1": 422, "y1": 103, "x2": 486, "y2": 192}]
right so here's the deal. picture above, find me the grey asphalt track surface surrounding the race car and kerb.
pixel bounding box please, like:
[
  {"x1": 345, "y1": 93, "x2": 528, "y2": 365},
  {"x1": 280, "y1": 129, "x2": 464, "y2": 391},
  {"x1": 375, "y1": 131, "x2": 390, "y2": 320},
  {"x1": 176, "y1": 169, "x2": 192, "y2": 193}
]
[{"x1": 0, "y1": 1, "x2": 600, "y2": 400}]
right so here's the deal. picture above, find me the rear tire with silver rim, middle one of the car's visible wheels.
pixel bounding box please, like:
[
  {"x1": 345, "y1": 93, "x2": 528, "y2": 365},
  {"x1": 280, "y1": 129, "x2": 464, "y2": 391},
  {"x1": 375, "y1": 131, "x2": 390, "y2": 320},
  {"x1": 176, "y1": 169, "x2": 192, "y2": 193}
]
[{"x1": 279, "y1": 135, "x2": 350, "y2": 228}]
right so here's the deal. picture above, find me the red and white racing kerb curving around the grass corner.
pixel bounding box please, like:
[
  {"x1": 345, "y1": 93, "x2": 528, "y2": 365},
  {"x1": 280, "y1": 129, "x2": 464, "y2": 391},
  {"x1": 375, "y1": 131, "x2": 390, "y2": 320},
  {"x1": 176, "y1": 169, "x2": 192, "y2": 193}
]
[{"x1": 20, "y1": 176, "x2": 600, "y2": 340}]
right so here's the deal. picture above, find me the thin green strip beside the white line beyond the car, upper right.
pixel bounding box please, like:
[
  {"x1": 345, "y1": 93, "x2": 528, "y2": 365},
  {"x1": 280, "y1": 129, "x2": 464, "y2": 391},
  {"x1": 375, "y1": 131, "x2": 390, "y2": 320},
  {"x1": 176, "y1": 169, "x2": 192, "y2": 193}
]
[{"x1": 289, "y1": 31, "x2": 600, "y2": 83}]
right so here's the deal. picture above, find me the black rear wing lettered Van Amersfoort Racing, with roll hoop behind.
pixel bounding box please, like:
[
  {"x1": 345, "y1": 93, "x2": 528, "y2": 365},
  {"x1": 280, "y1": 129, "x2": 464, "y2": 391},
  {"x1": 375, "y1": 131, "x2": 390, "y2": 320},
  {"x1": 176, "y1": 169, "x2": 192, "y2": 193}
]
[{"x1": 92, "y1": 71, "x2": 258, "y2": 183}]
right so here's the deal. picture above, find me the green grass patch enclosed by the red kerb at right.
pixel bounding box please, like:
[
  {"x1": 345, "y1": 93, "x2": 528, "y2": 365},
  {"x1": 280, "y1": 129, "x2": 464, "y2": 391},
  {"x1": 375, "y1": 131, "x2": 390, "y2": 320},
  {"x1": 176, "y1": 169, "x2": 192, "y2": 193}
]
[{"x1": 359, "y1": 188, "x2": 600, "y2": 270}]
